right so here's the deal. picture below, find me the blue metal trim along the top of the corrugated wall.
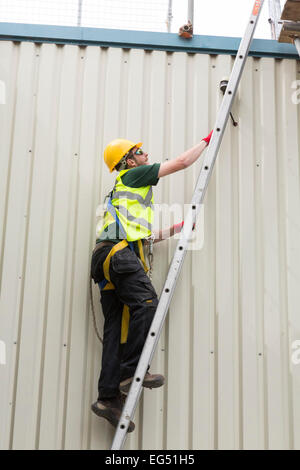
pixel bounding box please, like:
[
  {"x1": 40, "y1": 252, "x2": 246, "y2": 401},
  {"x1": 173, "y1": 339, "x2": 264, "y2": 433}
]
[{"x1": 0, "y1": 23, "x2": 299, "y2": 59}]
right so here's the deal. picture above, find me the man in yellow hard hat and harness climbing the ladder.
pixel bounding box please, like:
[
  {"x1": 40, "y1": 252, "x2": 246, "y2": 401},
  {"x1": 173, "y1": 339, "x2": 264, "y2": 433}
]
[{"x1": 91, "y1": 132, "x2": 212, "y2": 432}]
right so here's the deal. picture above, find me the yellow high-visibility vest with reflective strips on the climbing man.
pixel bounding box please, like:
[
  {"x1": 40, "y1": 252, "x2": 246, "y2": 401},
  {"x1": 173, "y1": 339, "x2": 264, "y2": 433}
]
[{"x1": 97, "y1": 170, "x2": 154, "y2": 241}]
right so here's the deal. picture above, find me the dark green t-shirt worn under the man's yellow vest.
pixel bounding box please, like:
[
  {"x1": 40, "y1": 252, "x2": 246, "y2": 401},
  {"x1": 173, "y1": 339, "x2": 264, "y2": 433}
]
[{"x1": 96, "y1": 163, "x2": 160, "y2": 251}]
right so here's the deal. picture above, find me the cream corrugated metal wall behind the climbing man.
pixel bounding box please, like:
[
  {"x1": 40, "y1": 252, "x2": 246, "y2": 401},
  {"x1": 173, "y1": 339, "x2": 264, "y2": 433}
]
[{"x1": 0, "y1": 41, "x2": 300, "y2": 449}]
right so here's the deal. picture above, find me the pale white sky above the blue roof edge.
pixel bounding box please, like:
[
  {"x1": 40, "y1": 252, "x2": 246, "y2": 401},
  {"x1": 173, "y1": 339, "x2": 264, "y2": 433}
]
[{"x1": 0, "y1": 0, "x2": 285, "y2": 39}]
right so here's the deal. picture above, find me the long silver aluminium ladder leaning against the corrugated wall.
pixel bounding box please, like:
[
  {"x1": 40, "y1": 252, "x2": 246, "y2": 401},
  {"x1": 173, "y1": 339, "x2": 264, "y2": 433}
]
[{"x1": 111, "y1": 0, "x2": 264, "y2": 450}]
